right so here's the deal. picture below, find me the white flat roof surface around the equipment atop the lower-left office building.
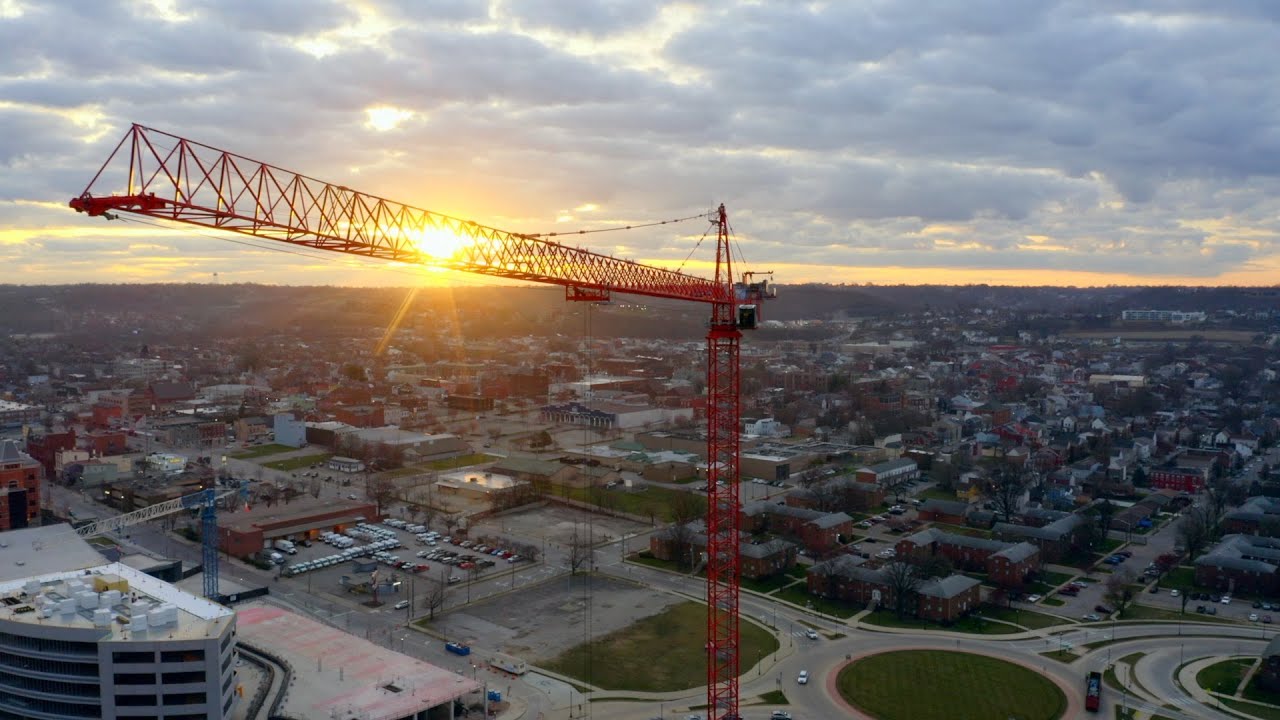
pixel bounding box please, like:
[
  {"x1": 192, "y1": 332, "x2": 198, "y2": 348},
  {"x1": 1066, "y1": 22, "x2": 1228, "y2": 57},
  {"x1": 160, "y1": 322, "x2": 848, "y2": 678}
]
[{"x1": 0, "y1": 562, "x2": 236, "y2": 641}]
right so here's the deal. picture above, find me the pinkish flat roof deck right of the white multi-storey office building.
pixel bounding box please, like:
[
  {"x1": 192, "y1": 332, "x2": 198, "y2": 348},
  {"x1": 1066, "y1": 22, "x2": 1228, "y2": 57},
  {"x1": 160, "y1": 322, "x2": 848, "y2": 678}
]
[{"x1": 237, "y1": 602, "x2": 481, "y2": 717}]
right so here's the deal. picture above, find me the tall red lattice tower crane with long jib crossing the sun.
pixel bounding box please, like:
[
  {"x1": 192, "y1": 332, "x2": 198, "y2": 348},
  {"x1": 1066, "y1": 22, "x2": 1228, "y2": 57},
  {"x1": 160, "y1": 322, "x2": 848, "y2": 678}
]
[{"x1": 70, "y1": 124, "x2": 774, "y2": 720}]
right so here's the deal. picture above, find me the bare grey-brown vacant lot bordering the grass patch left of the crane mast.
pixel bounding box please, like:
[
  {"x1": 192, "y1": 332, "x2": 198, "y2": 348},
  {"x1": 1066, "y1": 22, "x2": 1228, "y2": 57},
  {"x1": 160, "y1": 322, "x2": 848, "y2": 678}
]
[{"x1": 440, "y1": 575, "x2": 680, "y2": 664}]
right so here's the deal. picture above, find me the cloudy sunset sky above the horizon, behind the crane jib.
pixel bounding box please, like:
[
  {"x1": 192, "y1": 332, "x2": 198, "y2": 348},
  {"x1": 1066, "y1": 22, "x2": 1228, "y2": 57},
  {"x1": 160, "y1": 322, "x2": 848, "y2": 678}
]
[{"x1": 0, "y1": 0, "x2": 1280, "y2": 286}]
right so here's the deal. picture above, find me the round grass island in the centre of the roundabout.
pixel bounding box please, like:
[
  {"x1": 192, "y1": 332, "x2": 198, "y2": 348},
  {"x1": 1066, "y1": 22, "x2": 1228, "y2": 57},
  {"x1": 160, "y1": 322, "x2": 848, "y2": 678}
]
[{"x1": 836, "y1": 651, "x2": 1066, "y2": 720}]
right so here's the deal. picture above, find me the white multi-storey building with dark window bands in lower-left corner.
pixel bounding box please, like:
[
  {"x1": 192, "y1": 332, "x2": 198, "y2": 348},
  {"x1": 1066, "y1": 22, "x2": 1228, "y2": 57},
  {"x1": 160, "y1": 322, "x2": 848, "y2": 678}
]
[{"x1": 0, "y1": 525, "x2": 237, "y2": 720}]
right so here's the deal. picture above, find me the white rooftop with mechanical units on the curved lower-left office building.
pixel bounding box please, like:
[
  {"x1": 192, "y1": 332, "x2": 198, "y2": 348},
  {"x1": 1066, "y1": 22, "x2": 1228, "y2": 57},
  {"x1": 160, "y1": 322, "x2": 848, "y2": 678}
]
[{"x1": 0, "y1": 562, "x2": 236, "y2": 641}]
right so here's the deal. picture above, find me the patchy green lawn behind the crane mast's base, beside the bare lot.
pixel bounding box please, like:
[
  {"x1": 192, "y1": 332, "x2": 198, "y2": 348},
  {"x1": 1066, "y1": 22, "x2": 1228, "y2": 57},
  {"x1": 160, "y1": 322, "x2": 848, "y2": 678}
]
[{"x1": 541, "y1": 594, "x2": 778, "y2": 692}]
